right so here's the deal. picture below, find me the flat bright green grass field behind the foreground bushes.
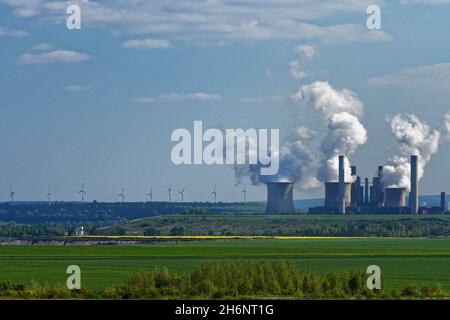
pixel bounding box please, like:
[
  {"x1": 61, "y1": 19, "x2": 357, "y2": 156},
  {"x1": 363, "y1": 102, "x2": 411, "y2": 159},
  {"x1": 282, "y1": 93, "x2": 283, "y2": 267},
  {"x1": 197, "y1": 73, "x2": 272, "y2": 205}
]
[{"x1": 0, "y1": 238, "x2": 450, "y2": 291}]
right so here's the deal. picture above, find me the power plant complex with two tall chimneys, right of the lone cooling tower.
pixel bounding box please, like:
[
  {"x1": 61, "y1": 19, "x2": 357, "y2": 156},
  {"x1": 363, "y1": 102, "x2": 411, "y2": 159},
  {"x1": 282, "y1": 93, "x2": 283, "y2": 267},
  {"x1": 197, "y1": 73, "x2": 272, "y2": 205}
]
[{"x1": 310, "y1": 155, "x2": 448, "y2": 214}]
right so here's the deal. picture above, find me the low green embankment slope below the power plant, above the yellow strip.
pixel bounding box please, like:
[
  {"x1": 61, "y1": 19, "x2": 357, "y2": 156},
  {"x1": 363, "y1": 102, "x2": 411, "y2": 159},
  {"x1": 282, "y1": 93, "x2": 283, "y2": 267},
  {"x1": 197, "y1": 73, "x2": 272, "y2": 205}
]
[{"x1": 102, "y1": 214, "x2": 450, "y2": 237}]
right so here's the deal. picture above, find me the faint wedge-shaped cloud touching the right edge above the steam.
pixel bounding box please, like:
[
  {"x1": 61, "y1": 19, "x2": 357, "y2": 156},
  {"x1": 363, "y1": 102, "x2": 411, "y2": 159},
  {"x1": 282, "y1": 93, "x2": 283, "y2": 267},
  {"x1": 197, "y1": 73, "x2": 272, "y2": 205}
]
[{"x1": 367, "y1": 63, "x2": 450, "y2": 90}]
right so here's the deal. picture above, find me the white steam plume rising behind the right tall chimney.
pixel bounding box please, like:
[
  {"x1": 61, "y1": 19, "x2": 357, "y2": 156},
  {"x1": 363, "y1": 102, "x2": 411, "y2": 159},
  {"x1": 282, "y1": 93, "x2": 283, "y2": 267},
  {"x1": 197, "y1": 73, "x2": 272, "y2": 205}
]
[{"x1": 381, "y1": 114, "x2": 440, "y2": 191}]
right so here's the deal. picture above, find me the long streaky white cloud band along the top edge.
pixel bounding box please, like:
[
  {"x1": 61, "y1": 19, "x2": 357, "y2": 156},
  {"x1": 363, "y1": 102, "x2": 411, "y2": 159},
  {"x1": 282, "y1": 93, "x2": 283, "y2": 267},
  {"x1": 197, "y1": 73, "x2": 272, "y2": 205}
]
[{"x1": 0, "y1": 0, "x2": 391, "y2": 43}]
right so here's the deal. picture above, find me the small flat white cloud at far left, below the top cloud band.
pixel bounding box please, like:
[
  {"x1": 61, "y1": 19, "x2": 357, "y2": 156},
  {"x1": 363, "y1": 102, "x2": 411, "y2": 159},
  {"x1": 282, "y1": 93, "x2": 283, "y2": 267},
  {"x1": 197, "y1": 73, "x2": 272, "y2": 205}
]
[{"x1": 19, "y1": 50, "x2": 90, "y2": 64}]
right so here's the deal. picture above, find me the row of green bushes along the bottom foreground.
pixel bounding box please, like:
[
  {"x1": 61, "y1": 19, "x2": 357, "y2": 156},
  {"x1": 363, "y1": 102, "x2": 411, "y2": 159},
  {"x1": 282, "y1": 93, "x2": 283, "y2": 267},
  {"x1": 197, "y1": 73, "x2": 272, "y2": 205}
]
[{"x1": 0, "y1": 260, "x2": 449, "y2": 299}]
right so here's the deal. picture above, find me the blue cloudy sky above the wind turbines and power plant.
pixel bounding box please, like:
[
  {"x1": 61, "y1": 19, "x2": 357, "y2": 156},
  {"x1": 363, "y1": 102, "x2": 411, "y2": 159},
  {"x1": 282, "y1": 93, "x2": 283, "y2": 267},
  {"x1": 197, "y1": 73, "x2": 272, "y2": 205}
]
[{"x1": 0, "y1": 0, "x2": 450, "y2": 201}]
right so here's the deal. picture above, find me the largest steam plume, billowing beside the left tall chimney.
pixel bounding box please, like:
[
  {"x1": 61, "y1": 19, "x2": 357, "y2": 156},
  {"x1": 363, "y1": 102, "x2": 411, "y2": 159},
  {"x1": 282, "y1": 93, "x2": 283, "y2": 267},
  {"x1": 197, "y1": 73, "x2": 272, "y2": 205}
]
[{"x1": 235, "y1": 81, "x2": 367, "y2": 190}]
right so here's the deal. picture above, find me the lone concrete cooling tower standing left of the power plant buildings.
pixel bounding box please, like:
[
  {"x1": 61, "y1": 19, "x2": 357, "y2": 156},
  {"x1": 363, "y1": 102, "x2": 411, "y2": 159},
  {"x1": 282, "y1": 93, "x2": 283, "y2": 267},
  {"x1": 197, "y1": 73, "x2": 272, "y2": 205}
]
[{"x1": 266, "y1": 182, "x2": 295, "y2": 214}]
